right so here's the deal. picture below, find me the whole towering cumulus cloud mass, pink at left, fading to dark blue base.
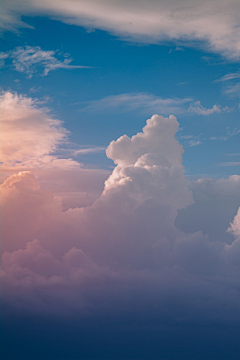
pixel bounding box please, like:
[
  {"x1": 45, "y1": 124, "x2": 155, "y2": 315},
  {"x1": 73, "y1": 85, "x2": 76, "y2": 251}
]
[{"x1": 1, "y1": 109, "x2": 240, "y2": 324}]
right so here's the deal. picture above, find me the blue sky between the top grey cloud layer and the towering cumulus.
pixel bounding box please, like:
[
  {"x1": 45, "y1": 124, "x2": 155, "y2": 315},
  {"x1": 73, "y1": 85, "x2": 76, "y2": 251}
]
[{"x1": 1, "y1": 17, "x2": 240, "y2": 177}]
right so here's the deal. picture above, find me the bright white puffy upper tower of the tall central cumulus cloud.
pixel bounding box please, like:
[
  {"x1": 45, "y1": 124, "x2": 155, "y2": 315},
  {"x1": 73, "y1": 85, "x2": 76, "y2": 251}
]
[{"x1": 103, "y1": 115, "x2": 191, "y2": 210}]
